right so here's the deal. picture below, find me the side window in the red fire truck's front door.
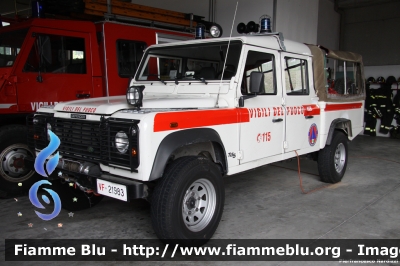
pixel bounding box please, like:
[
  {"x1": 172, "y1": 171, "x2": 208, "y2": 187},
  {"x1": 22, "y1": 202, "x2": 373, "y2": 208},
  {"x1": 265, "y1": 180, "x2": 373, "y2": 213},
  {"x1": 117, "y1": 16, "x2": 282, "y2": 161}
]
[{"x1": 24, "y1": 34, "x2": 86, "y2": 74}]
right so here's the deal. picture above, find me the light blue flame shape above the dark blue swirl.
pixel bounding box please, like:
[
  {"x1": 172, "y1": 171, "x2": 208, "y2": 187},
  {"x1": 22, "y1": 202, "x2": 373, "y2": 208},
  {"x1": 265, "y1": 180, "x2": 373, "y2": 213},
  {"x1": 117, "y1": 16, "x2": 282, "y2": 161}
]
[{"x1": 35, "y1": 129, "x2": 60, "y2": 177}]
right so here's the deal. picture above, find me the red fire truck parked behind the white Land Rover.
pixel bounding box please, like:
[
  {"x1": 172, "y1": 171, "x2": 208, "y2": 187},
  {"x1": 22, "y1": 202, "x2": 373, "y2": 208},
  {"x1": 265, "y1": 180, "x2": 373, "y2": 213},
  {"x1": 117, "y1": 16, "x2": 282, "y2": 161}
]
[{"x1": 0, "y1": 11, "x2": 219, "y2": 196}]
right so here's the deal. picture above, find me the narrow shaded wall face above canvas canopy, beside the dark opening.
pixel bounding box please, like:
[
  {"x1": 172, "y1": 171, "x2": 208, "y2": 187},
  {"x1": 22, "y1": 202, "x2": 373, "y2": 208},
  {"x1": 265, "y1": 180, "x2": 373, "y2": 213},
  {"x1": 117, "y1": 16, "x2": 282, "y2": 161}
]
[{"x1": 316, "y1": 0, "x2": 340, "y2": 50}]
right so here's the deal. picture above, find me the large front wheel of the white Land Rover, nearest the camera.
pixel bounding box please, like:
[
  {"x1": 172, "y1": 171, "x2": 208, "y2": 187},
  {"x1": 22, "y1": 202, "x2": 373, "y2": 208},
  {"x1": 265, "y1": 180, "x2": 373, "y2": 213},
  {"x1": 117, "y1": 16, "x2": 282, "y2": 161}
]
[{"x1": 151, "y1": 156, "x2": 225, "y2": 246}]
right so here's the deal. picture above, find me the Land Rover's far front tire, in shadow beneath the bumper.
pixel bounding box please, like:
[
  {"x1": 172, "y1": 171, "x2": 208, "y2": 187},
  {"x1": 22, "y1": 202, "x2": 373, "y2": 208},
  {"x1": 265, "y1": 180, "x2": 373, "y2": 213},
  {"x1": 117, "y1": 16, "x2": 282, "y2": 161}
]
[{"x1": 49, "y1": 180, "x2": 103, "y2": 211}]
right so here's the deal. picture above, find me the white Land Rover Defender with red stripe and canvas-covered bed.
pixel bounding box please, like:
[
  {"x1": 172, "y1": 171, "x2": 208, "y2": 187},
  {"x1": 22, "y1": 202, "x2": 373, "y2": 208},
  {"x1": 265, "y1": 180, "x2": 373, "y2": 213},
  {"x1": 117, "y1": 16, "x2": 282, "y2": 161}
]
[{"x1": 27, "y1": 34, "x2": 365, "y2": 243}]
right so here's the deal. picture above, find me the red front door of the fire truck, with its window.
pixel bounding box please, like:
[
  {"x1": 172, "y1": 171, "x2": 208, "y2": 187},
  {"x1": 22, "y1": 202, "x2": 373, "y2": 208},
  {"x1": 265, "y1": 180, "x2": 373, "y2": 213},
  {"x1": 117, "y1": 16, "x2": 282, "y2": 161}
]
[{"x1": 16, "y1": 28, "x2": 93, "y2": 111}]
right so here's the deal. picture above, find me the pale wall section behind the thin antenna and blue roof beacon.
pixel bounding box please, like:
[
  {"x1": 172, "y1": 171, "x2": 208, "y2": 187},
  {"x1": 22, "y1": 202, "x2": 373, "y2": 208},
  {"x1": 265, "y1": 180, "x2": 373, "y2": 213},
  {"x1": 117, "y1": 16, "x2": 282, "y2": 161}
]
[{"x1": 216, "y1": 0, "x2": 281, "y2": 37}]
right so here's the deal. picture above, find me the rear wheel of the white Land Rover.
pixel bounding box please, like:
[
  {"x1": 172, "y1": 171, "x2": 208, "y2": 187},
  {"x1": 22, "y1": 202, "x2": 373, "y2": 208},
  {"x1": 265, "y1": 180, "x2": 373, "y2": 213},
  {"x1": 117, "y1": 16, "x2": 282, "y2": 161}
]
[{"x1": 318, "y1": 131, "x2": 347, "y2": 183}]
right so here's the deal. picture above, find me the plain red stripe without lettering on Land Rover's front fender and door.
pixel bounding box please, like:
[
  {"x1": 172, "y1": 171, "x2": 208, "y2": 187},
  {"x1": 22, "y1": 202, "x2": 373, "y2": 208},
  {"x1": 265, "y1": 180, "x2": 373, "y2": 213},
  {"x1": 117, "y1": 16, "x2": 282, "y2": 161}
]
[{"x1": 154, "y1": 108, "x2": 250, "y2": 132}]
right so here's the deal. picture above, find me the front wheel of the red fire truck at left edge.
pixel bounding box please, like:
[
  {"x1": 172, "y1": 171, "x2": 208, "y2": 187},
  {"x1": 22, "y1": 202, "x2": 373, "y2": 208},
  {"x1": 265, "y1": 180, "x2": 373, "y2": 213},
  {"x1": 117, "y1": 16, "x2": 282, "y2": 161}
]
[{"x1": 0, "y1": 125, "x2": 41, "y2": 197}]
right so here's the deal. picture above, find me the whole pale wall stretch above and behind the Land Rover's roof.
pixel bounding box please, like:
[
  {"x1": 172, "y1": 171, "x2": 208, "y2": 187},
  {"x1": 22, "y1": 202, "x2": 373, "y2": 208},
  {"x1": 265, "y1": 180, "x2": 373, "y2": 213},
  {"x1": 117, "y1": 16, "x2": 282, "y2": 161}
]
[{"x1": 132, "y1": 0, "x2": 339, "y2": 45}]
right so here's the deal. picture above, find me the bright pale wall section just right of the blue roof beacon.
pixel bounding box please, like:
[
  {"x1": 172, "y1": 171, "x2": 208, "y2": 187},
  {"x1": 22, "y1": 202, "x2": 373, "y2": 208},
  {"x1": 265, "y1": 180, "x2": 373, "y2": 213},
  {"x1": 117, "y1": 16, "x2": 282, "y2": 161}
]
[{"x1": 276, "y1": 0, "x2": 319, "y2": 44}]
